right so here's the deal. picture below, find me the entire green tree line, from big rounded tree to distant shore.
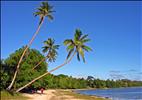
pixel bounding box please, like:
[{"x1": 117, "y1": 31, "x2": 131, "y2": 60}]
[{"x1": 0, "y1": 48, "x2": 142, "y2": 90}]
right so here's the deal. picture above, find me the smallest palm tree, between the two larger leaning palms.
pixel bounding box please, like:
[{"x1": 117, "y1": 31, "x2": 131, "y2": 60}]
[{"x1": 33, "y1": 38, "x2": 59, "y2": 70}]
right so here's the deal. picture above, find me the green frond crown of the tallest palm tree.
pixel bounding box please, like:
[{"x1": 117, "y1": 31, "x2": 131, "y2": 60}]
[{"x1": 34, "y1": 2, "x2": 54, "y2": 23}]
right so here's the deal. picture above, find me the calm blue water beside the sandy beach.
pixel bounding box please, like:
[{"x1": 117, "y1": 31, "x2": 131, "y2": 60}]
[{"x1": 76, "y1": 87, "x2": 142, "y2": 100}]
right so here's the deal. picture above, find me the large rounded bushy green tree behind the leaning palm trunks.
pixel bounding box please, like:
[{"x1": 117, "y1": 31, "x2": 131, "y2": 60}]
[{"x1": 1, "y1": 47, "x2": 47, "y2": 89}]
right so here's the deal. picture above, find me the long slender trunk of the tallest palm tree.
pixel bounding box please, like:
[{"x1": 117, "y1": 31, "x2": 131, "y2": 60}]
[{"x1": 7, "y1": 18, "x2": 44, "y2": 90}]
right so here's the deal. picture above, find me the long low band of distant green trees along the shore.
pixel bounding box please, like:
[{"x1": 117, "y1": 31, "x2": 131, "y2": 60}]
[{"x1": 39, "y1": 74, "x2": 142, "y2": 89}]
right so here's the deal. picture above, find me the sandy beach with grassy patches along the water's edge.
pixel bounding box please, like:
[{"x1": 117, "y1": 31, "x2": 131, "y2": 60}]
[{"x1": 1, "y1": 87, "x2": 142, "y2": 100}]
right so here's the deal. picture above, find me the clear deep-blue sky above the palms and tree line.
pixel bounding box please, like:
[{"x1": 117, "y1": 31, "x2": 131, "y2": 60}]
[{"x1": 1, "y1": 1, "x2": 142, "y2": 80}]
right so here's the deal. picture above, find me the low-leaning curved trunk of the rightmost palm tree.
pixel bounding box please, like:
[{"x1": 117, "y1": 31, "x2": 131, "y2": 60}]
[{"x1": 16, "y1": 51, "x2": 76, "y2": 92}]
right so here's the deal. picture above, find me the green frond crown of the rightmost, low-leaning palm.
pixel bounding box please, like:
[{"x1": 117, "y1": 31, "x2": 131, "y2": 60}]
[{"x1": 64, "y1": 29, "x2": 92, "y2": 62}]
